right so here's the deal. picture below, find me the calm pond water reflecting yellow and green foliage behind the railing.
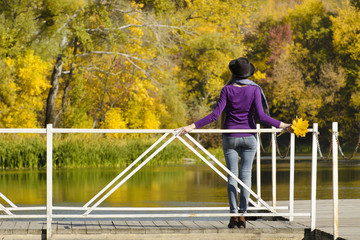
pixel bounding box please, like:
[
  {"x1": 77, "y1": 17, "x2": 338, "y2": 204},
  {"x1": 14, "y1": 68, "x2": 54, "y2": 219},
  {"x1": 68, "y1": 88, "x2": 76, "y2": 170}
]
[{"x1": 0, "y1": 162, "x2": 360, "y2": 207}]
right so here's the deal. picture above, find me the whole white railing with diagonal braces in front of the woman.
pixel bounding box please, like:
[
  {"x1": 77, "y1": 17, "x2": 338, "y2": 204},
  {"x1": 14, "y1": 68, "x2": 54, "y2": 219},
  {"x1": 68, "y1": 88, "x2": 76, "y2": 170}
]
[{"x1": 0, "y1": 123, "x2": 337, "y2": 238}]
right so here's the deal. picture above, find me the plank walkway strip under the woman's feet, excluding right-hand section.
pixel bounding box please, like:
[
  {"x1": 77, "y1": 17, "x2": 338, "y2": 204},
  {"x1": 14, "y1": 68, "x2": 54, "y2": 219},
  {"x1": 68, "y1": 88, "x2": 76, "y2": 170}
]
[{"x1": 0, "y1": 221, "x2": 305, "y2": 240}]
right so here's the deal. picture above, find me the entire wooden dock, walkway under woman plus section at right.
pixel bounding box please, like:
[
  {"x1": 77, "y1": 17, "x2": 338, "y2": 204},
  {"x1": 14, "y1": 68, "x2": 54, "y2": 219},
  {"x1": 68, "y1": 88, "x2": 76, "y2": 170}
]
[{"x1": 0, "y1": 199, "x2": 360, "y2": 240}]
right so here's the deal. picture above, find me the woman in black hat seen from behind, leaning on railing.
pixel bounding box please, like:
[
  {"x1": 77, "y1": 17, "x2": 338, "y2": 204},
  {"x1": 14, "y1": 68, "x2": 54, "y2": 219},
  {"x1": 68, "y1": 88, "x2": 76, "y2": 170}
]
[{"x1": 177, "y1": 57, "x2": 290, "y2": 228}]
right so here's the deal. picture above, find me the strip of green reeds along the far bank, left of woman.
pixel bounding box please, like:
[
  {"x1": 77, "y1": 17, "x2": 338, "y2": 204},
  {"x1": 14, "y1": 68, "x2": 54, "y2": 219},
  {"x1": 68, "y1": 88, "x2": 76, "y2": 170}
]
[{"x1": 0, "y1": 134, "x2": 198, "y2": 169}]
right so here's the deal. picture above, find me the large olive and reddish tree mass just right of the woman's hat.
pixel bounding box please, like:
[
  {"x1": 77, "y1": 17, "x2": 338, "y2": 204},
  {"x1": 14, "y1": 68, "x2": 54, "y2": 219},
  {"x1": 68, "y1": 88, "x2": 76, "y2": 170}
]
[{"x1": 245, "y1": 0, "x2": 358, "y2": 146}]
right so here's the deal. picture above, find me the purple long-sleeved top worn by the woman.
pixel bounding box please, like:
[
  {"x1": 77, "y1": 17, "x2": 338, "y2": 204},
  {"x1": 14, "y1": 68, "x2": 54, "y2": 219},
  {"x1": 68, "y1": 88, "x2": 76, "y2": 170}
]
[{"x1": 195, "y1": 85, "x2": 281, "y2": 137}]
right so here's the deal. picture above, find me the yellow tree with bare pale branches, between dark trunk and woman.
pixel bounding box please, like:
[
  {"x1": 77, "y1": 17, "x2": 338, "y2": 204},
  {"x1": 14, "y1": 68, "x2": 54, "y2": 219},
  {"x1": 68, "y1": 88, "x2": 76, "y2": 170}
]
[{"x1": 43, "y1": 2, "x2": 188, "y2": 128}]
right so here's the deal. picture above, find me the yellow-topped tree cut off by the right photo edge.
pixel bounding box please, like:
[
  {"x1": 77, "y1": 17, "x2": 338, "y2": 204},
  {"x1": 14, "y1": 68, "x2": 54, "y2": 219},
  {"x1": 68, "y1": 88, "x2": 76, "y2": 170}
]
[{"x1": 331, "y1": 1, "x2": 360, "y2": 140}]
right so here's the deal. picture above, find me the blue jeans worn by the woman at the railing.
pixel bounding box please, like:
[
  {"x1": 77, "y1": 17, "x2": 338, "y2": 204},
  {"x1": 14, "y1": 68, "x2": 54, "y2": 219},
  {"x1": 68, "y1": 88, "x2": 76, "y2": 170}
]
[{"x1": 223, "y1": 135, "x2": 257, "y2": 213}]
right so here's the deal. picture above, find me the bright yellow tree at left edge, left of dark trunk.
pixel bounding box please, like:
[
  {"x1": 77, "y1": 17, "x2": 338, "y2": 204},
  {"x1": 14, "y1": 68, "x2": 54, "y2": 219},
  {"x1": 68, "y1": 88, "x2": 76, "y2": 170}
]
[{"x1": 0, "y1": 1, "x2": 50, "y2": 127}]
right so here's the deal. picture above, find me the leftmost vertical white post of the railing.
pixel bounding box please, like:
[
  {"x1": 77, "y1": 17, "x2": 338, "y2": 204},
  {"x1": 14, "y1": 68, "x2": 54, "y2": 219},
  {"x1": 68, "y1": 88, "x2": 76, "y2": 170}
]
[{"x1": 46, "y1": 124, "x2": 53, "y2": 239}]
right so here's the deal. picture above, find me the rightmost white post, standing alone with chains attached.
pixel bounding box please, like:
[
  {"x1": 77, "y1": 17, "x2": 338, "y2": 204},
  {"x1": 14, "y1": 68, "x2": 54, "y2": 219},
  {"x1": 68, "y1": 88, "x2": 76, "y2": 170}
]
[{"x1": 332, "y1": 122, "x2": 339, "y2": 239}]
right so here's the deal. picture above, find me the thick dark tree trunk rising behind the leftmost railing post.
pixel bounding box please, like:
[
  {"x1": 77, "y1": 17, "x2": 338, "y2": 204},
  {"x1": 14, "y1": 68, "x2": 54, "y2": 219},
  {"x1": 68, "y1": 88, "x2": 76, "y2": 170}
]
[{"x1": 45, "y1": 55, "x2": 63, "y2": 127}]
